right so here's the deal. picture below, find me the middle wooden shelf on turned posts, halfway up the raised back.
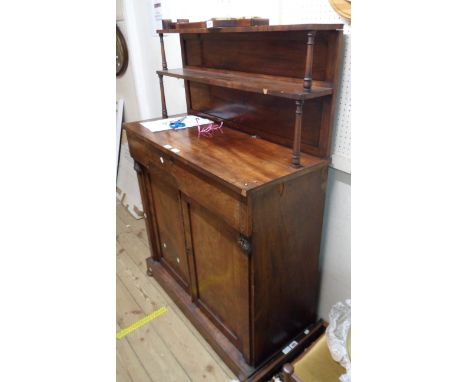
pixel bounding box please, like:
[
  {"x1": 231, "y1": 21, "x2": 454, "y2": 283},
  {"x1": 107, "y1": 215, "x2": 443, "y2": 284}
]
[{"x1": 158, "y1": 67, "x2": 333, "y2": 100}]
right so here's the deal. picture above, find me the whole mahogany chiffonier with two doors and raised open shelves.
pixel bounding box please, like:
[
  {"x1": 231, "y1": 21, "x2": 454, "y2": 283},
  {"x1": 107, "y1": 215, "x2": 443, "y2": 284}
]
[{"x1": 125, "y1": 24, "x2": 342, "y2": 380}]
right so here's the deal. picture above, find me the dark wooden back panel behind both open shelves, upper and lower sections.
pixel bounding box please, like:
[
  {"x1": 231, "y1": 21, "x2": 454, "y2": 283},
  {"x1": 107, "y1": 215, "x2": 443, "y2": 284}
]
[{"x1": 180, "y1": 30, "x2": 342, "y2": 158}]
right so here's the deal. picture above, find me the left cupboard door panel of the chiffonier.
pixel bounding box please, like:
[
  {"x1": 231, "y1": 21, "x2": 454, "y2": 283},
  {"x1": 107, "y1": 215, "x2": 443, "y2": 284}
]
[{"x1": 151, "y1": 175, "x2": 190, "y2": 290}]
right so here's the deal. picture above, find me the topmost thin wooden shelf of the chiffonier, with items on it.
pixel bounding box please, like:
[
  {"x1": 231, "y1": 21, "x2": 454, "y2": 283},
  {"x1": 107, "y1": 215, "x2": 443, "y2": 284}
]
[{"x1": 157, "y1": 24, "x2": 343, "y2": 34}]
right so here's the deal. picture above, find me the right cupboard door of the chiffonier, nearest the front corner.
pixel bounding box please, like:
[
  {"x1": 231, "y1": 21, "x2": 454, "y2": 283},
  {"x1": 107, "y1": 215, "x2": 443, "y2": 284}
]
[{"x1": 188, "y1": 202, "x2": 250, "y2": 360}]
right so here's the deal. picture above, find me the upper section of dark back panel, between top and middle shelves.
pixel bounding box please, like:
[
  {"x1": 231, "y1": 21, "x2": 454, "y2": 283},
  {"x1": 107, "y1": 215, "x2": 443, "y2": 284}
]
[{"x1": 181, "y1": 31, "x2": 337, "y2": 82}]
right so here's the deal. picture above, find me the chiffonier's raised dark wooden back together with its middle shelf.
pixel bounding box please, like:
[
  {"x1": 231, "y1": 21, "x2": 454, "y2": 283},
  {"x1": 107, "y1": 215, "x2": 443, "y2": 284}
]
[{"x1": 179, "y1": 26, "x2": 342, "y2": 160}]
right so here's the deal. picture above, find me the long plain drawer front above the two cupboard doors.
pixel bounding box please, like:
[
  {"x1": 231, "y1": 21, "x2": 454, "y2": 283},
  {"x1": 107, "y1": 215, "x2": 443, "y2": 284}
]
[{"x1": 129, "y1": 136, "x2": 251, "y2": 236}]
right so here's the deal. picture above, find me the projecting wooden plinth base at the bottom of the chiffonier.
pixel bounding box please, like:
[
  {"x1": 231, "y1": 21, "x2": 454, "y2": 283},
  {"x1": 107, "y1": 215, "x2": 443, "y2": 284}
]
[{"x1": 146, "y1": 257, "x2": 324, "y2": 382}]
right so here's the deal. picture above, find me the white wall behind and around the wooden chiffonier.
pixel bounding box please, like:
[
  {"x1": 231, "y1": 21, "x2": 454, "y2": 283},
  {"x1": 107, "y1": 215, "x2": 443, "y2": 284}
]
[{"x1": 121, "y1": 0, "x2": 351, "y2": 319}]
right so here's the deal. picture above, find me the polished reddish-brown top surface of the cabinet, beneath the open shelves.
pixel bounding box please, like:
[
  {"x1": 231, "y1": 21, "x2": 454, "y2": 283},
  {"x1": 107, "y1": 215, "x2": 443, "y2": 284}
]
[{"x1": 125, "y1": 122, "x2": 328, "y2": 196}]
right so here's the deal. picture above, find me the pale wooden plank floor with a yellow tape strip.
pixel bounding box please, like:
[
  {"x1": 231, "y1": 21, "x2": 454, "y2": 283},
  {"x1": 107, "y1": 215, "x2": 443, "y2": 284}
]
[{"x1": 116, "y1": 202, "x2": 237, "y2": 382}]
